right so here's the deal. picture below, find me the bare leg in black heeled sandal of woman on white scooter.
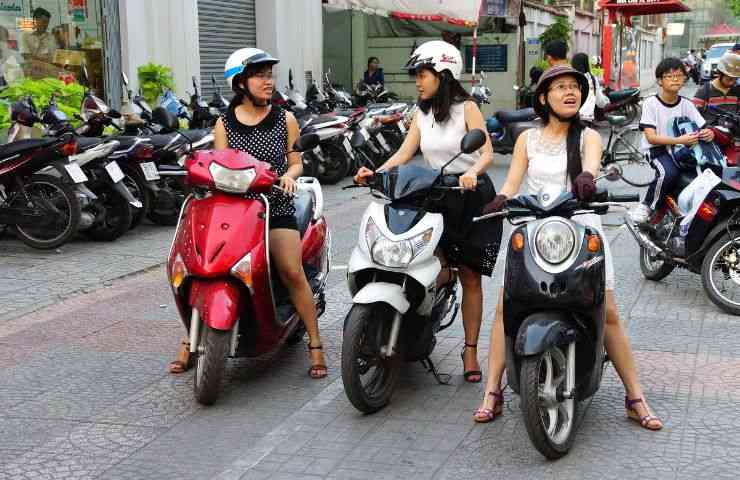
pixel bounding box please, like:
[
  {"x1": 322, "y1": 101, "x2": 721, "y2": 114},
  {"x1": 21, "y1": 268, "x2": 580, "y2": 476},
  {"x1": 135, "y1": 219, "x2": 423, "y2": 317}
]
[{"x1": 459, "y1": 266, "x2": 483, "y2": 382}]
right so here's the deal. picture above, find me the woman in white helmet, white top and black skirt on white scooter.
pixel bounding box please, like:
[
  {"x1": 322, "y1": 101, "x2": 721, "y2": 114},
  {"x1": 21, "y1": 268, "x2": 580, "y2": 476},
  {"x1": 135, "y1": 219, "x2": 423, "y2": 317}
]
[{"x1": 355, "y1": 41, "x2": 501, "y2": 383}]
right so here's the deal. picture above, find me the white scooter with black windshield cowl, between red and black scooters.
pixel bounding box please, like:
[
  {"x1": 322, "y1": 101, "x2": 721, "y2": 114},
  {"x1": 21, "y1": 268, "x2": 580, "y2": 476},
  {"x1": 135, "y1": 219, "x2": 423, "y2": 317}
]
[{"x1": 342, "y1": 130, "x2": 486, "y2": 413}]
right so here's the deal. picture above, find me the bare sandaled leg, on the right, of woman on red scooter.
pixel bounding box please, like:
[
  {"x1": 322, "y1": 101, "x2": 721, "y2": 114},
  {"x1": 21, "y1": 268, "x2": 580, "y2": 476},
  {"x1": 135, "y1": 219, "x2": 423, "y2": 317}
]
[{"x1": 270, "y1": 228, "x2": 326, "y2": 377}]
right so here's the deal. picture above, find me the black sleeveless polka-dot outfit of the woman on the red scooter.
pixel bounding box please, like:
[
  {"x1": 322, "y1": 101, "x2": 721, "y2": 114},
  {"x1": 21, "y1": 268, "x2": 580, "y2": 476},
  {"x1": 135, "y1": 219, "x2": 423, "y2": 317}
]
[{"x1": 221, "y1": 106, "x2": 295, "y2": 218}]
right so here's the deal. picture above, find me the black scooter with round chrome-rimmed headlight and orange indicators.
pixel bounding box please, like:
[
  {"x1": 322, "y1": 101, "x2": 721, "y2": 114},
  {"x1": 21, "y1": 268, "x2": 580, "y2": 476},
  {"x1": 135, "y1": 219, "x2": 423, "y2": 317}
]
[{"x1": 476, "y1": 179, "x2": 638, "y2": 459}]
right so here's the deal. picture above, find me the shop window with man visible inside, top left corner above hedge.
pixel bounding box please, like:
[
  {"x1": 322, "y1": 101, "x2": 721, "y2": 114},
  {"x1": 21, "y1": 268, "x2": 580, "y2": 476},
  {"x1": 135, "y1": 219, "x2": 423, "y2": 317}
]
[{"x1": 0, "y1": 0, "x2": 104, "y2": 93}]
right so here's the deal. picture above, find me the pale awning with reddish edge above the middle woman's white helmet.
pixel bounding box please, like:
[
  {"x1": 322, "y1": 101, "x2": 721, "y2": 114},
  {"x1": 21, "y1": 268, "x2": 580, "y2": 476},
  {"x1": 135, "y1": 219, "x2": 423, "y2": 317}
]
[{"x1": 324, "y1": 0, "x2": 481, "y2": 26}]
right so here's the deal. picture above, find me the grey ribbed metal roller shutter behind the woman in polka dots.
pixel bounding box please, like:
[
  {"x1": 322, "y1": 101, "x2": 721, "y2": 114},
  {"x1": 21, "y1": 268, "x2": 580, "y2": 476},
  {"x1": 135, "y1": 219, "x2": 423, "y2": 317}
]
[{"x1": 198, "y1": 0, "x2": 257, "y2": 97}]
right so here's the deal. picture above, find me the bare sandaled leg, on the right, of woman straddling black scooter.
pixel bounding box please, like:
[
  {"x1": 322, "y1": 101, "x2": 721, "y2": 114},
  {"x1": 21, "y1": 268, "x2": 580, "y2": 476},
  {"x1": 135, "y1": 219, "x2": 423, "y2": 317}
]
[{"x1": 604, "y1": 290, "x2": 662, "y2": 427}]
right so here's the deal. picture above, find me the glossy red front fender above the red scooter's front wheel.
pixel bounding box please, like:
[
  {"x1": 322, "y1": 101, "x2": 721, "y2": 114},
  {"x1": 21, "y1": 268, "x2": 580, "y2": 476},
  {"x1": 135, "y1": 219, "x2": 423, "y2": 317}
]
[{"x1": 190, "y1": 279, "x2": 241, "y2": 331}]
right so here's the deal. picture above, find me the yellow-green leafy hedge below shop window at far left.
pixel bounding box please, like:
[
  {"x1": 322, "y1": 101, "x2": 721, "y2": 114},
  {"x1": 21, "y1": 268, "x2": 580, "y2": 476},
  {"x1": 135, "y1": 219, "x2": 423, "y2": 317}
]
[{"x1": 0, "y1": 78, "x2": 85, "y2": 130}]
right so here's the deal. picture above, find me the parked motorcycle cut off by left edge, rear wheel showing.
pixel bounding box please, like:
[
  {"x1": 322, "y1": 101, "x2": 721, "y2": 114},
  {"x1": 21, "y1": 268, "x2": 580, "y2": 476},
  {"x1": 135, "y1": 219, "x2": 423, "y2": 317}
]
[{"x1": 0, "y1": 135, "x2": 81, "y2": 249}]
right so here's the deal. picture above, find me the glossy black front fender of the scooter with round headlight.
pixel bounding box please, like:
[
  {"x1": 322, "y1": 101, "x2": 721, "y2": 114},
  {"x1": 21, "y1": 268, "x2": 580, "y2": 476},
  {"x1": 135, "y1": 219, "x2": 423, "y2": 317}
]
[{"x1": 514, "y1": 312, "x2": 578, "y2": 356}]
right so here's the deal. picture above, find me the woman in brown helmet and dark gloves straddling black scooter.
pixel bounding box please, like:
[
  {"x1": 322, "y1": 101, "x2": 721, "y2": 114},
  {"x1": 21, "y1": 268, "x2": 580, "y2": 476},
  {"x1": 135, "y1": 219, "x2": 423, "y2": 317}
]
[{"x1": 473, "y1": 65, "x2": 663, "y2": 430}]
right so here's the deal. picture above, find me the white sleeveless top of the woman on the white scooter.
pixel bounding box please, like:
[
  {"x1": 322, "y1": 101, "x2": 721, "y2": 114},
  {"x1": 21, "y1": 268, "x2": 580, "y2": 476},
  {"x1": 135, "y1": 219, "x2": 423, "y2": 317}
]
[{"x1": 416, "y1": 102, "x2": 480, "y2": 173}]
